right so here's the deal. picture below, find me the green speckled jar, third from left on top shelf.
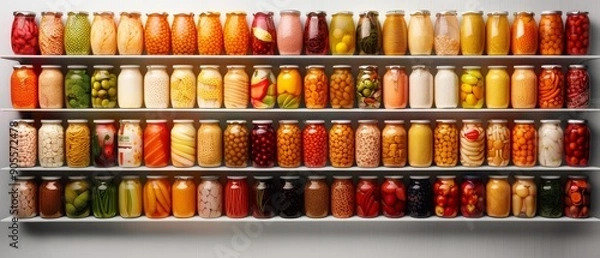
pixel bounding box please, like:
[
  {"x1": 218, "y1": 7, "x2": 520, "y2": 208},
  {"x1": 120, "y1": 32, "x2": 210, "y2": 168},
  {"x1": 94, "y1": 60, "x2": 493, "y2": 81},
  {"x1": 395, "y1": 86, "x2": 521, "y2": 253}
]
[{"x1": 64, "y1": 12, "x2": 92, "y2": 55}]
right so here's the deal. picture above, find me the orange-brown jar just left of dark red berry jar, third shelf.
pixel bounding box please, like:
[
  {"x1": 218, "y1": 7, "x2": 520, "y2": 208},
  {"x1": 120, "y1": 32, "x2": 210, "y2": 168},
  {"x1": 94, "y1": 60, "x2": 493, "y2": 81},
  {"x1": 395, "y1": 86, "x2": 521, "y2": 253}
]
[{"x1": 223, "y1": 120, "x2": 250, "y2": 168}]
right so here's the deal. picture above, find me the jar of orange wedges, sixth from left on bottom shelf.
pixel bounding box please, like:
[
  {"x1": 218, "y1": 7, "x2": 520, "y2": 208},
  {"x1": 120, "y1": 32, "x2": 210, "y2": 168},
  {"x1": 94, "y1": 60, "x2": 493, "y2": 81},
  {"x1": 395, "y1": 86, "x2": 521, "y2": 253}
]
[{"x1": 144, "y1": 175, "x2": 171, "y2": 219}]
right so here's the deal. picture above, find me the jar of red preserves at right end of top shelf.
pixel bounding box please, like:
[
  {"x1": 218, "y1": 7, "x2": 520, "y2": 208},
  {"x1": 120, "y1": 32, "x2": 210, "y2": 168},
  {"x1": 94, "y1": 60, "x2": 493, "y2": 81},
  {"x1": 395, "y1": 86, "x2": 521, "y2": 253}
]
[{"x1": 565, "y1": 11, "x2": 590, "y2": 55}]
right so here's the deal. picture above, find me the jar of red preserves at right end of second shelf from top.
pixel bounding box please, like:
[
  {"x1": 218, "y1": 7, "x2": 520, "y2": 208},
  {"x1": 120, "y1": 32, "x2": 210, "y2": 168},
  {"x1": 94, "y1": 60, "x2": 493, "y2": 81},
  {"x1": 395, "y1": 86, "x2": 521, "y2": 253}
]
[{"x1": 565, "y1": 65, "x2": 590, "y2": 108}]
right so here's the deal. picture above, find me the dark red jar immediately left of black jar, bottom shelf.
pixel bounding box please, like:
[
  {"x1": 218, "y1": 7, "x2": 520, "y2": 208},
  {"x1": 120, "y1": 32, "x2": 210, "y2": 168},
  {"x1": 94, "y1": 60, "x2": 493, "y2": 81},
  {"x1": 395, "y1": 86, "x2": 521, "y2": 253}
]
[{"x1": 380, "y1": 176, "x2": 406, "y2": 218}]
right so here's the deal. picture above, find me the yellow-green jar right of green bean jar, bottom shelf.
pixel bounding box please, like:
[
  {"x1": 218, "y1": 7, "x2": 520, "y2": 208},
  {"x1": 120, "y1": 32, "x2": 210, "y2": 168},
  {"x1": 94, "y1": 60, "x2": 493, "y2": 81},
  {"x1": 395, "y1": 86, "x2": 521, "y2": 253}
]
[{"x1": 119, "y1": 176, "x2": 144, "y2": 218}]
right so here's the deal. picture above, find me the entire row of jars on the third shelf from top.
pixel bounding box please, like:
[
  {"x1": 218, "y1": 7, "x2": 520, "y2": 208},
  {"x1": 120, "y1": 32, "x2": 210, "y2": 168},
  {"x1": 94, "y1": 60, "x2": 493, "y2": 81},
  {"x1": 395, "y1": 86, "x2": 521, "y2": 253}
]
[{"x1": 10, "y1": 119, "x2": 591, "y2": 168}]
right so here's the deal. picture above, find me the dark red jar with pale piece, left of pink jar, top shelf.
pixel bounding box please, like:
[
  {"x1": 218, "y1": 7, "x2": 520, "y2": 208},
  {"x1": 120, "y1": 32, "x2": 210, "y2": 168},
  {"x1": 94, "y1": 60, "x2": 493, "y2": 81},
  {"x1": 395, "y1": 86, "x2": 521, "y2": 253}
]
[{"x1": 250, "y1": 12, "x2": 277, "y2": 55}]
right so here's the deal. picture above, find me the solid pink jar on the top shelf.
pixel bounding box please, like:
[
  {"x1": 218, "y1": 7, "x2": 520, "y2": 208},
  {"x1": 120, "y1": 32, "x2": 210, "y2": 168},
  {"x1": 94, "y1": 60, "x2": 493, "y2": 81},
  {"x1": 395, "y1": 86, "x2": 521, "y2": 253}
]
[{"x1": 276, "y1": 10, "x2": 302, "y2": 55}]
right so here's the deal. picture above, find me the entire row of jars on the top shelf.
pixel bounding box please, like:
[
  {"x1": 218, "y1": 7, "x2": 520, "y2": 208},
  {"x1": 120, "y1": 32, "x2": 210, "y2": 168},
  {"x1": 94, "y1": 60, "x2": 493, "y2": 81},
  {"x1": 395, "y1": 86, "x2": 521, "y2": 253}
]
[{"x1": 11, "y1": 10, "x2": 590, "y2": 55}]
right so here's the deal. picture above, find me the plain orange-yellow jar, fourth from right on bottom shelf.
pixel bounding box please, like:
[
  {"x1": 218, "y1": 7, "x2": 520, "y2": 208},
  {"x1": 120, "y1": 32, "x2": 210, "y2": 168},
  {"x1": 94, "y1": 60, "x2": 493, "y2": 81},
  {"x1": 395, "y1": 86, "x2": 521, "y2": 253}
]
[{"x1": 485, "y1": 175, "x2": 511, "y2": 218}]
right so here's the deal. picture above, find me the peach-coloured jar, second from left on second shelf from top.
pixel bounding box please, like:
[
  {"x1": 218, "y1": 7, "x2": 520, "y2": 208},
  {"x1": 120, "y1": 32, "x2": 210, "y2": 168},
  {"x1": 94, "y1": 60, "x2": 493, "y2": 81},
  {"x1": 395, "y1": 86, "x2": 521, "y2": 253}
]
[{"x1": 37, "y1": 65, "x2": 65, "y2": 108}]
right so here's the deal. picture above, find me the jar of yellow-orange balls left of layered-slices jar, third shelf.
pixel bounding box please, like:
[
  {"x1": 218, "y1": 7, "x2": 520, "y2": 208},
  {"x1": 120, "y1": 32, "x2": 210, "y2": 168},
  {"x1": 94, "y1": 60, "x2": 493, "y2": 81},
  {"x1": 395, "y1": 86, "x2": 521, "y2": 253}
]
[{"x1": 433, "y1": 120, "x2": 458, "y2": 168}]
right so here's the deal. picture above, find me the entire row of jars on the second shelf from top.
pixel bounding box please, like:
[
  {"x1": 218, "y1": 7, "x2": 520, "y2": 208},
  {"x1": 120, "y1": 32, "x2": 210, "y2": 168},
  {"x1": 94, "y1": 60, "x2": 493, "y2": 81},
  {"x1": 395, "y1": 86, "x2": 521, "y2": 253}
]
[{"x1": 11, "y1": 65, "x2": 590, "y2": 109}]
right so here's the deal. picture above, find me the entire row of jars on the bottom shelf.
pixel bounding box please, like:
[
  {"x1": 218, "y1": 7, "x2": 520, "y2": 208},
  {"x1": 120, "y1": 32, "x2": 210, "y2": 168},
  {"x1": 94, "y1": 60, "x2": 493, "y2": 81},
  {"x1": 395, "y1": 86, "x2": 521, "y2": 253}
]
[{"x1": 11, "y1": 175, "x2": 591, "y2": 218}]
